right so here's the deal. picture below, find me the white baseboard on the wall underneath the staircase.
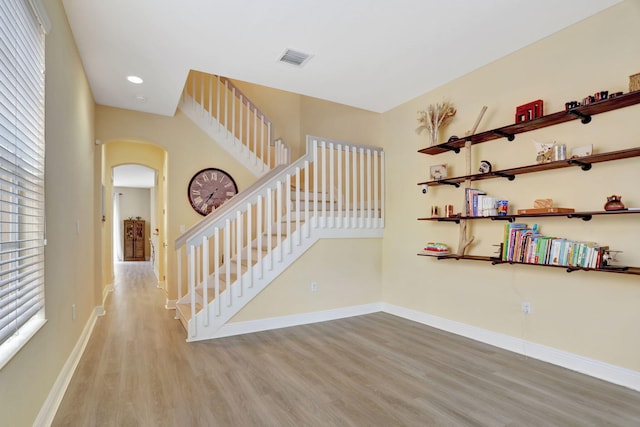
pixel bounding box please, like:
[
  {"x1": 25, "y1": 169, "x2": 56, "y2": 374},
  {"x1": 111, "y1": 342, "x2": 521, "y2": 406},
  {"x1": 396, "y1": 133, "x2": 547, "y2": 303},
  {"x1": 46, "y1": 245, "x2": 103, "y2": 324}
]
[{"x1": 214, "y1": 303, "x2": 382, "y2": 338}]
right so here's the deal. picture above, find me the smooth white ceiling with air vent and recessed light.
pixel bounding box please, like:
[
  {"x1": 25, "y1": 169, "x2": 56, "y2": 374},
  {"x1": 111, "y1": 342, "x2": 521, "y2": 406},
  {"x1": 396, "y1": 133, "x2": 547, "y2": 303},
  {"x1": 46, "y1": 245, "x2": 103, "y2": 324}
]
[{"x1": 62, "y1": 0, "x2": 620, "y2": 116}]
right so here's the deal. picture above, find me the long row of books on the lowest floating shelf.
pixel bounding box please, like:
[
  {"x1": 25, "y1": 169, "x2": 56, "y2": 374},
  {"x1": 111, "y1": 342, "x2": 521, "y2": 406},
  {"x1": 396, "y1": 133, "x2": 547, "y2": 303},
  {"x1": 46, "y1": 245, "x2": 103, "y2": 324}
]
[{"x1": 502, "y1": 223, "x2": 609, "y2": 268}]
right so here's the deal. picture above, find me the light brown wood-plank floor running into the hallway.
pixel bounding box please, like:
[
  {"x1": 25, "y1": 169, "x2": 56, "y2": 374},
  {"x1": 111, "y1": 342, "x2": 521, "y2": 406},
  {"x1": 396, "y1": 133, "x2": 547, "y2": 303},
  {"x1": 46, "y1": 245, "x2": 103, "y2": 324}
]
[{"x1": 53, "y1": 263, "x2": 640, "y2": 427}]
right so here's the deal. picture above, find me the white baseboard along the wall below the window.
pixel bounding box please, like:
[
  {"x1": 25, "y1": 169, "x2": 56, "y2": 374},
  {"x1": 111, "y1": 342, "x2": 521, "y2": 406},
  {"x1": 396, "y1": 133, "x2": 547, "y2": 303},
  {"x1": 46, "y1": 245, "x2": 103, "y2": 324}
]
[{"x1": 33, "y1": 306, "x2": 104, "y2": 427}]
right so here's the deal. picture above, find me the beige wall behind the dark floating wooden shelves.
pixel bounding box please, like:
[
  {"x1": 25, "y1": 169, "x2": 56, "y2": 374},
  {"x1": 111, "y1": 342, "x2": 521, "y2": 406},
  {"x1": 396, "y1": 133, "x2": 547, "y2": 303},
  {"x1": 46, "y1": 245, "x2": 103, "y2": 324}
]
[{"x1": 382, "y1": 1, "x2": 640, "y2": 371}]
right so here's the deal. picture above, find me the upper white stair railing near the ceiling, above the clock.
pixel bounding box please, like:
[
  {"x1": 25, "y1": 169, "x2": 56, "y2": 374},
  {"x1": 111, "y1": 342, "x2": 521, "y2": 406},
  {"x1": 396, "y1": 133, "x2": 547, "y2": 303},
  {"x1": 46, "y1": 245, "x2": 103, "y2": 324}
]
[{"x1": 179, "y1": 70, "x2": 290, "y2": 176}]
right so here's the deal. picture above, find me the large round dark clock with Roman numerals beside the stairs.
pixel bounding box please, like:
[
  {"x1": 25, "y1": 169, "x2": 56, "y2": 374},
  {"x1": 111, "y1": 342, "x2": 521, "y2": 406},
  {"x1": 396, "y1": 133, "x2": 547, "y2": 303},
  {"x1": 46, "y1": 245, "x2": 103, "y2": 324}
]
[{"x1": 187, "y1": 168, "x2": 238, "y2": 216}]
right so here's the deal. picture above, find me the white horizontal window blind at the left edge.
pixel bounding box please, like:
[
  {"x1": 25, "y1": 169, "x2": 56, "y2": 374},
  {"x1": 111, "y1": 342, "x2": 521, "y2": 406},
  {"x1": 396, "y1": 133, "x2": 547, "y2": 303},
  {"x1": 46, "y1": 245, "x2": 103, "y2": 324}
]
[{"x1": 0, "y1": 0, "x2": 45, "y2": 366}]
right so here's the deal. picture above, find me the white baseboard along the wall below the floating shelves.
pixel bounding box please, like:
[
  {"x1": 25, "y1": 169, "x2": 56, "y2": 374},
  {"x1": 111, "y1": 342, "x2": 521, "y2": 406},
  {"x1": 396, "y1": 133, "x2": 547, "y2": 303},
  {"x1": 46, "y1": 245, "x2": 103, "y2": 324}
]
[{"x1": 382, "y1": 304, "x2": 640, "y2": 391}]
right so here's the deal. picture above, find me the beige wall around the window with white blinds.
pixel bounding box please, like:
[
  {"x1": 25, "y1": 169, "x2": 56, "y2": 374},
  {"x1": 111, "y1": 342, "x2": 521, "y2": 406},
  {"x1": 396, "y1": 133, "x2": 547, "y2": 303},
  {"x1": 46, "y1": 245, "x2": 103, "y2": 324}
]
[{"x1": 0, "y1": 0, "x2": 101, "y2": 426}]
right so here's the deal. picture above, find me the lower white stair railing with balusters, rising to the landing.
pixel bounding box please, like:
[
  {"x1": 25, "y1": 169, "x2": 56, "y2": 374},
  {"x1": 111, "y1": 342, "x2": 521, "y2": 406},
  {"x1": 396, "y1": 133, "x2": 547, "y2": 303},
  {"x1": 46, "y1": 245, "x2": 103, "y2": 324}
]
[{"x1": 176, "y1": 137, "x2": 384, "y2": 341}]
